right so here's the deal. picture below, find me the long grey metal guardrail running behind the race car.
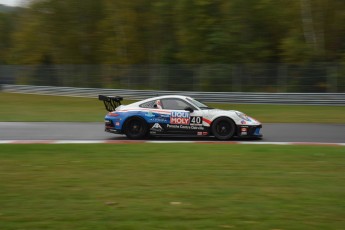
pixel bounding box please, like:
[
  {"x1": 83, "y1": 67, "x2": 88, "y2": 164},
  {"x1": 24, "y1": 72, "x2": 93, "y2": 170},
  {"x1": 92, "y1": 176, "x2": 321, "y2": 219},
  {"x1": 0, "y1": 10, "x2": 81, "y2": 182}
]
[{"x1": 1, "y1": 84, "x2": 345, "y2": 106}]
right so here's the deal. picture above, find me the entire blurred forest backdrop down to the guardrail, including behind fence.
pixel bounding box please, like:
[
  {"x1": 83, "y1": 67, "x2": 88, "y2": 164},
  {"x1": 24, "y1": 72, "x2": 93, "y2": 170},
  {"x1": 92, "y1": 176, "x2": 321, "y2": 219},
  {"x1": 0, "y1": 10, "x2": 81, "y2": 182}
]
[{"x1": 0, "y1": 0, "x2": 345, "y2": 92}]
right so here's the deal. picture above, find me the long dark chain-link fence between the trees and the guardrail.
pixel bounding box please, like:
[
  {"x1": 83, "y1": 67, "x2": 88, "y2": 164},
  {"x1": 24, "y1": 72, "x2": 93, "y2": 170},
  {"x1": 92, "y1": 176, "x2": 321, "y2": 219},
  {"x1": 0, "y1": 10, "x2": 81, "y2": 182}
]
[{"x1": 0, "y1": 63, "x2": 345, "y2": 93}]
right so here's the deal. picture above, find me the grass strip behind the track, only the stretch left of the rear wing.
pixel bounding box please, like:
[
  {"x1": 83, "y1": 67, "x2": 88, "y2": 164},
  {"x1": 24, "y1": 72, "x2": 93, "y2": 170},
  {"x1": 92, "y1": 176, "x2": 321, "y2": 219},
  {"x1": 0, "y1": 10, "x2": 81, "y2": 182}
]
[{"x1": 0, "y1": 93, "x2": 106, "y2": 121}]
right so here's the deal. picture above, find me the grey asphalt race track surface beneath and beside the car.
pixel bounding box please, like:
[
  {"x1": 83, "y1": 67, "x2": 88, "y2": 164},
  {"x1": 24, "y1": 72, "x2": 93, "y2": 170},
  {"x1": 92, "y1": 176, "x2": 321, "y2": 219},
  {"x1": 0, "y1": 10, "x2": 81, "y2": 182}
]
[{"x1": 0, "y1": 122, "x2": 345, "y2": 143}]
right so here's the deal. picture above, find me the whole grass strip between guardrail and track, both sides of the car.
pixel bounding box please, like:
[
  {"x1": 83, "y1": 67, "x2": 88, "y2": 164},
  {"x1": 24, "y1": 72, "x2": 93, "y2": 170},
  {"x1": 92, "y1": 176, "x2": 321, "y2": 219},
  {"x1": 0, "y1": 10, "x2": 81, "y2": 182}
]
[{"x1": 0, "y1": 93, "x2": 345, "y2": 124}]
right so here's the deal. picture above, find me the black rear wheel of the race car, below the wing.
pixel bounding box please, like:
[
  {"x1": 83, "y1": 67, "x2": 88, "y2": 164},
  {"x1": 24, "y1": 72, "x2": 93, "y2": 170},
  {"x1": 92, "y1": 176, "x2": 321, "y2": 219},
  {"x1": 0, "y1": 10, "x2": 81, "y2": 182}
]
[{"x1": 124, "y1": 117, "x2": 149, "y2": 140}]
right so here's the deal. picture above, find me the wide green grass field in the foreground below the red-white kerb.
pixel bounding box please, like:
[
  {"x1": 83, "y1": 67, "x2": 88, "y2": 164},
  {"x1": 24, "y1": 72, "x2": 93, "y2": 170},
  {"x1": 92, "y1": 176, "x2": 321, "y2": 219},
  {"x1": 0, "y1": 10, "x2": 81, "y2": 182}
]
[{"x1": 0, "y1": 144, "x2": 345, "y2": 230}]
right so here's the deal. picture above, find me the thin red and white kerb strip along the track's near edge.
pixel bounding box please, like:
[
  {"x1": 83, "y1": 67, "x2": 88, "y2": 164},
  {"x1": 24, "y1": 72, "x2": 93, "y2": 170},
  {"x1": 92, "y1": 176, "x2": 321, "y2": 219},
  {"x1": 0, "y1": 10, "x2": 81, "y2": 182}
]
[{"x1": 0, "y1": 140, "x2": 345, "y2": 146}]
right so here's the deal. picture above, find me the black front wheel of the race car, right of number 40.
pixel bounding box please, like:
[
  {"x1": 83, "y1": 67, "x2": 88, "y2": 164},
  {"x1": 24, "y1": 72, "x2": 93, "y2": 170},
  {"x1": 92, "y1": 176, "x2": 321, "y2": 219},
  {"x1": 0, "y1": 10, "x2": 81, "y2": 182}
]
[{"x1": 211, "y1": 117, "x2": 236, "y2": 141}]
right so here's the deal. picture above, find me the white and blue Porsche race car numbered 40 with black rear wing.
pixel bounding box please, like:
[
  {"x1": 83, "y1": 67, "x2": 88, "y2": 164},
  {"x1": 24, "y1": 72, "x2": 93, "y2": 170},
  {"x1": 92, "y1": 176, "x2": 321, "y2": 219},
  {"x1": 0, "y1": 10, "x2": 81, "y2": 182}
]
[{"x1": 98, "y1": 95, "x2": 262, "y2": 140}]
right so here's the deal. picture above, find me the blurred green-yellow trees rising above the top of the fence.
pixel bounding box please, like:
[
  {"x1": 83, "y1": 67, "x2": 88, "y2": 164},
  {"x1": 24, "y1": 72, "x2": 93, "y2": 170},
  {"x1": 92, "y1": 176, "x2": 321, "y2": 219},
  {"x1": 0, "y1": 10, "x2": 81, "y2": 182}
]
[{"x1": 5, "y1": 0, "x2": 345, "y2": 64}]
